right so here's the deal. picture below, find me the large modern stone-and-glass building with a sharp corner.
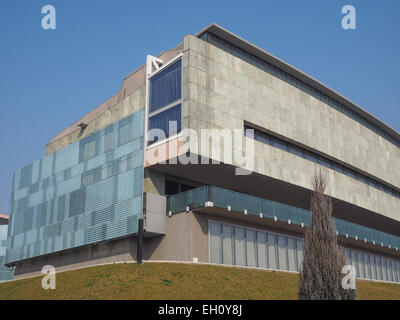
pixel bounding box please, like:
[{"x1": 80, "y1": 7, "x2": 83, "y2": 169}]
[{"x1": 6, "y1": 24, "x2": 400, "y2": 282}]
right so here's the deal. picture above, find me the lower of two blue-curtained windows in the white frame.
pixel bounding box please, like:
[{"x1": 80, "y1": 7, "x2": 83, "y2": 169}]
[{"x1": 148, "y1": 104, "x2": 181, "y2": 143}]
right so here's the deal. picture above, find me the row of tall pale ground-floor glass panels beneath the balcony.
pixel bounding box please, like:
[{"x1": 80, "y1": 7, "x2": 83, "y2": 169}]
[{"x1": 209, "y1": 221, "x2": 400, "y2": 282}]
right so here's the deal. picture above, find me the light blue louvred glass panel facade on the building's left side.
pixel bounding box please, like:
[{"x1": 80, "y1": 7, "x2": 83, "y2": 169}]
[{"x1": 6, "y1": 110, "x2": 144, "y2": 263}]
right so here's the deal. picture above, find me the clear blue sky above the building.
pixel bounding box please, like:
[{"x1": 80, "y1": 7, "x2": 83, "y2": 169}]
[{"x1": 0, "y1": 0, "x2": 400, "y2": 213}]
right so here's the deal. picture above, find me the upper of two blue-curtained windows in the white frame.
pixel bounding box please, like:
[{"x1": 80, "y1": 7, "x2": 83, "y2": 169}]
[{"x1": 149, "y1": 59, "x2": 182, "y2": 113}]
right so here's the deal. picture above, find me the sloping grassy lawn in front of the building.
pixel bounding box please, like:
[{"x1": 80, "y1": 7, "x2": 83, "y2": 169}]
[{"x1": 0, "y1": 263, "x2": 400, "y2": 300}]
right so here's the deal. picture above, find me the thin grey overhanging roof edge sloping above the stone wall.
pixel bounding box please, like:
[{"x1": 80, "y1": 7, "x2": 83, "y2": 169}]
[{"x1": 195, "y1": 23, "x2": 400, "y2": 142}]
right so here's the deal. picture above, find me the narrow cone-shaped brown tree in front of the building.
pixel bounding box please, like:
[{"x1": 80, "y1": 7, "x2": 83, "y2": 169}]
[{"x1": 299, "y1": 170, "x2": 357, "y2": 300}]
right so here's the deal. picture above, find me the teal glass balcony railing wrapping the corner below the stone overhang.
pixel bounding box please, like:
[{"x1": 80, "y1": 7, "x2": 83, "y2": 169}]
[{"x1": 169, "y1": 186, "x2": 400, "y2": 251}]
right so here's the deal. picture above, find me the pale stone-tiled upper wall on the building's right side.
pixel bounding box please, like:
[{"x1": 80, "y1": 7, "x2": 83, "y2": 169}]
[{"x1": 182, "y1": 35, "x2": 400, "y2": 220}]
